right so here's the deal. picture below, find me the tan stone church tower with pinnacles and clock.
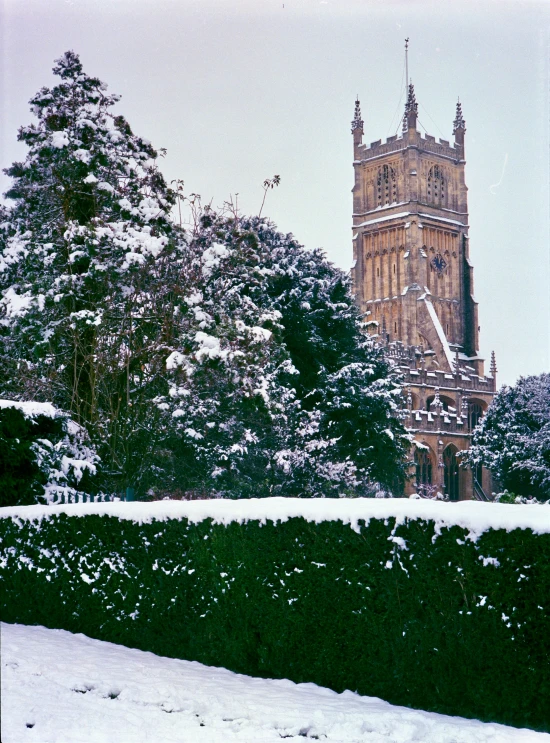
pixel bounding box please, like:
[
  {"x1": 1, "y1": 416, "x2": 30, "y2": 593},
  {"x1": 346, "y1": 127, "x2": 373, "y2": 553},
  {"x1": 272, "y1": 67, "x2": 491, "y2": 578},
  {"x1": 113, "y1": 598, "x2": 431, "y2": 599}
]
[{"x1": 351, "y1": 88, "x2": 496, "y2": 500}]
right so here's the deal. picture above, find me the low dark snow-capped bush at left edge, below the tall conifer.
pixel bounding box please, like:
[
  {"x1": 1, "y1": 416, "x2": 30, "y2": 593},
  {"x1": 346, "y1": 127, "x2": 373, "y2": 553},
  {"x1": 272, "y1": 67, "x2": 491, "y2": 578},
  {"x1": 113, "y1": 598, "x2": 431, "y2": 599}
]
[{"x1": 0, "y1": 400, "x2": 99, "y2": 506}]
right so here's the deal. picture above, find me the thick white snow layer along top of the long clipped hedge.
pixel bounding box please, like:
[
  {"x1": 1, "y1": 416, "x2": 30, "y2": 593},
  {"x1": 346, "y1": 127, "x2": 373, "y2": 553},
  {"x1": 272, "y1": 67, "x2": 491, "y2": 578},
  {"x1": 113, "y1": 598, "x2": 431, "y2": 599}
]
[{"x1": 0, "y1": 498, "x2": 550, "y2": 539}]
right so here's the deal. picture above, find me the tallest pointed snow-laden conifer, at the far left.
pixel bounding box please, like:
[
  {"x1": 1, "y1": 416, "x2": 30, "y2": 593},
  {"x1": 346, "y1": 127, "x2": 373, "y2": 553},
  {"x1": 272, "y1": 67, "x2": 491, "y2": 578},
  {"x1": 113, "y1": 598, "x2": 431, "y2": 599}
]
[{"x1": 0, "y1": 52, "x2": 179, "y2": 494}]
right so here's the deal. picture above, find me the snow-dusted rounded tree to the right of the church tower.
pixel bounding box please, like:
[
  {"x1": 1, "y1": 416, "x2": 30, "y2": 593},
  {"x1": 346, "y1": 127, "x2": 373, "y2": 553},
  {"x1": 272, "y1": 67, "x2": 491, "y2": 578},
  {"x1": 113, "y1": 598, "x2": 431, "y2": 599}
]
[{"x1": 465, "y1": 374, "x2": 550, "y2": 500}]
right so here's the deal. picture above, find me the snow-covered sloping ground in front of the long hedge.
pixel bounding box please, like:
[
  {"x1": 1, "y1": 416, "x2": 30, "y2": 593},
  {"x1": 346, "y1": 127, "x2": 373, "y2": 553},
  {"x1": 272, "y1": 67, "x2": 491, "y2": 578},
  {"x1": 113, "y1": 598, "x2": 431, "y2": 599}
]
[{"x1": 1, "y1": 623, "x2": 550, "y2": 743}]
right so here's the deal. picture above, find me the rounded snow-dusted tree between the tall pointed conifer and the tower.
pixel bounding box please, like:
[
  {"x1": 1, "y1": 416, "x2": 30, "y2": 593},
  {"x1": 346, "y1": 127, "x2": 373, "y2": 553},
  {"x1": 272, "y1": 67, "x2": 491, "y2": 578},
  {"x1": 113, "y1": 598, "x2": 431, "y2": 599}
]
[{"x1": 157, "y1": 210, "x2": 408, "y2": 497}]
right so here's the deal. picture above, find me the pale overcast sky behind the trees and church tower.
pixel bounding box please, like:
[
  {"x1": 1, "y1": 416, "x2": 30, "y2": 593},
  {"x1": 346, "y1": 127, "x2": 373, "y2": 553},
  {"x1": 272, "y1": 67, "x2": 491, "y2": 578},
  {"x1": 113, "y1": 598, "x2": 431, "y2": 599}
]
[{"x1": 0, "y1": 0, "x2": 550, "y2": 384}]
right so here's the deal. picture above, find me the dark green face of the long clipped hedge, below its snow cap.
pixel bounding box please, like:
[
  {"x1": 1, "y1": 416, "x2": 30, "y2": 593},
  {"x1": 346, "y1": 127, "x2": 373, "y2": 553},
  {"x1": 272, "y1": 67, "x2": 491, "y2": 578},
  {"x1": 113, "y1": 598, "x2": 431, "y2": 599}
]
[{"x1": 0, "y1": 514, "x2": 550, "y2": 729}]
